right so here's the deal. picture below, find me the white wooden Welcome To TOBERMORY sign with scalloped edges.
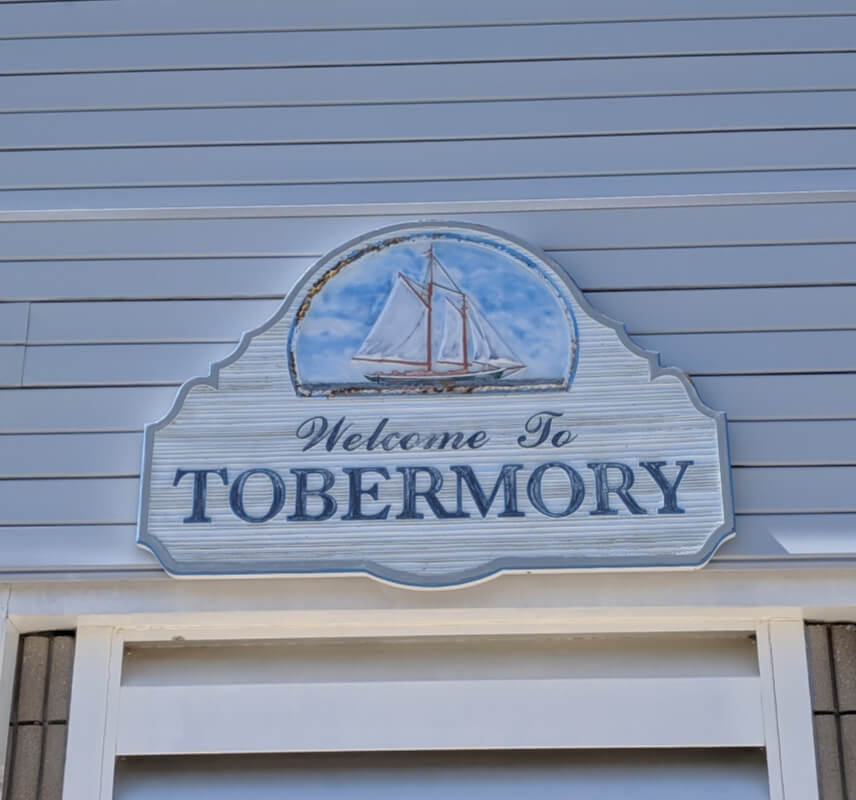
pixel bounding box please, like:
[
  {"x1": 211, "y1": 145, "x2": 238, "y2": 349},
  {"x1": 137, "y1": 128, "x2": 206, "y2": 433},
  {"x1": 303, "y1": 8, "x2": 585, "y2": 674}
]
[{"x1": 138, "y1": 222, "x2": 733, "y2": 586}]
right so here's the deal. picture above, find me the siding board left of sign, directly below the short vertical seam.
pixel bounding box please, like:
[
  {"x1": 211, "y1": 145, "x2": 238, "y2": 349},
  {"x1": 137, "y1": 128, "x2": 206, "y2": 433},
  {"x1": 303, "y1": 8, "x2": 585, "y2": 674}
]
[{"x1": 0, "y1": 386, "x2": 178, "y2": 433}]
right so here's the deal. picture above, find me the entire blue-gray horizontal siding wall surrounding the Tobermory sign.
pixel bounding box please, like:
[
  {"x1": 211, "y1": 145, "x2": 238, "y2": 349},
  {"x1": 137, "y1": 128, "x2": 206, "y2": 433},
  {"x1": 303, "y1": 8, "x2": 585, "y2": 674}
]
[{"x1": 0, "y1": 0, "x2": 856, "y2": 572}]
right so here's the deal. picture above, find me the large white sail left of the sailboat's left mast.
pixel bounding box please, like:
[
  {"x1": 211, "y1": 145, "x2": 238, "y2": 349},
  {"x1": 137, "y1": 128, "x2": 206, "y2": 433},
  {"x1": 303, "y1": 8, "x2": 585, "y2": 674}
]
[{"x1": 354, "y1": 275, "x2": 428, "y2": 364}]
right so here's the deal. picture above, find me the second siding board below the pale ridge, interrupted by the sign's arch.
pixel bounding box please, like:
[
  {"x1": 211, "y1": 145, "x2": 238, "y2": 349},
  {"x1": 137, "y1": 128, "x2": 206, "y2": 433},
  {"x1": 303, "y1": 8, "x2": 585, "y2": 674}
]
[{"x1": 2, "y1": 244, "x2": 856, "y2": 300}]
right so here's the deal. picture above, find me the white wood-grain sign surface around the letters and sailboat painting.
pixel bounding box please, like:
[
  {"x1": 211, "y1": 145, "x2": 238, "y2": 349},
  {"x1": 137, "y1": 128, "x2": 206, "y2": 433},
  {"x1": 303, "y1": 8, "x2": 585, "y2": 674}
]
[{"x1": 139, "y1": 223, "x2": 732, "y2": 585}]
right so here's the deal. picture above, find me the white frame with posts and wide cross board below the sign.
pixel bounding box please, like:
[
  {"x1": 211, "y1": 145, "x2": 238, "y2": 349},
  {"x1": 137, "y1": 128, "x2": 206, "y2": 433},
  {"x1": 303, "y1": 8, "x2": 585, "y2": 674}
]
[{"x1": 56, "y1": 609, "x2": 817, "y2": 800}]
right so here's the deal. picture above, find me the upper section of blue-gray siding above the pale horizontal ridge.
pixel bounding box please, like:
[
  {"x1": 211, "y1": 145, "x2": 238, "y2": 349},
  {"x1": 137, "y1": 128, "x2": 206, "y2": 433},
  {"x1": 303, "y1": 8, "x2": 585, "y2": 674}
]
[{"x1": 0, "y1": 14, "x2": 856, "y2": 209}]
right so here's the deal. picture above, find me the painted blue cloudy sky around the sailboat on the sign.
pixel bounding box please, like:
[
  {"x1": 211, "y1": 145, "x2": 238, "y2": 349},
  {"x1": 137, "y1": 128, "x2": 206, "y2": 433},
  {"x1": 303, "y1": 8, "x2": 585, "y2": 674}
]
[{"x1": 293, "y1": 236, "x2": 573, "y2": 384}]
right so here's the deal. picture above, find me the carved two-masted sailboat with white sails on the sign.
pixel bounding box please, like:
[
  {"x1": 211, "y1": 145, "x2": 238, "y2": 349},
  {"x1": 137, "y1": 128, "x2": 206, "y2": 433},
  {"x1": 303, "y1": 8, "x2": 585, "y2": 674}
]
[{"x1": 353, "y1": 244, "x2": 526, "y2": 388}]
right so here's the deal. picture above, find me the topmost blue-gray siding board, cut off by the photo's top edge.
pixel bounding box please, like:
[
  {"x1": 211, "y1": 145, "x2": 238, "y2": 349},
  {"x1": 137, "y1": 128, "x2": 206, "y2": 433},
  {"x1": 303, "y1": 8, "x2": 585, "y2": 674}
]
[{"x1": 0, "y1": 0, "x2": 853, "y2": 36}]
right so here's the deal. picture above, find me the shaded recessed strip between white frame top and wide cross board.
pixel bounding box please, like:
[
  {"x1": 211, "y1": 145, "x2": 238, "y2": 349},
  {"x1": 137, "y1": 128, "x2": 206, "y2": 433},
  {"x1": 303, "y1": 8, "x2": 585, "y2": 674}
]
[{"x1": 122, "y1": 629, "x2": 758, "y2": 688}]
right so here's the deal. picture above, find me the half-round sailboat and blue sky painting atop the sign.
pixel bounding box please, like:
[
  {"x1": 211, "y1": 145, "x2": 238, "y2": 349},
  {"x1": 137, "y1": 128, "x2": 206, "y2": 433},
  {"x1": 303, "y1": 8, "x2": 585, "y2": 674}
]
[{"x1": 289, "y1": 230, "x2": 577, "y2": 396}]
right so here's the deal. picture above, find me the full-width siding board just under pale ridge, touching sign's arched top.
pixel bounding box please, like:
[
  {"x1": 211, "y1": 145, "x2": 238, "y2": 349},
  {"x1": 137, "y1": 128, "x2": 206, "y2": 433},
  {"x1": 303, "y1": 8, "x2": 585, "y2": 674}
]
[{"x1": 2, "y1": 198, "x2": 856, "y2": 260}]
